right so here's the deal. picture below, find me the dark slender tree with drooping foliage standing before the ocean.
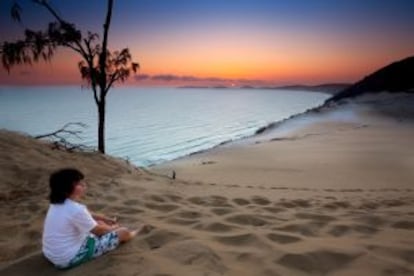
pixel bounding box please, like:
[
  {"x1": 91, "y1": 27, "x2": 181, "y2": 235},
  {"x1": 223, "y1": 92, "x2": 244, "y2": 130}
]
[{"x1": 0, "y1": 0, "x2": 139, "y2": 153}]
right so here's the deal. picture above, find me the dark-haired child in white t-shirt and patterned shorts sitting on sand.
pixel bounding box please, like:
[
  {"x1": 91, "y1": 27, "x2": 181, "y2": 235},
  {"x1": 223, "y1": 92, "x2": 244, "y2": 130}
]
[{"x1": 42, "y1": 169, "x2": 142, "y2": 269}]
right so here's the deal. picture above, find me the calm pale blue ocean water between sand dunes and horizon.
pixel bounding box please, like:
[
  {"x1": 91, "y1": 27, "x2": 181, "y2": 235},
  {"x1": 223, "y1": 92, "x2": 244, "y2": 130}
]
[{"x1": 0, "y1": 86, "x2": 329, "y2": 167}]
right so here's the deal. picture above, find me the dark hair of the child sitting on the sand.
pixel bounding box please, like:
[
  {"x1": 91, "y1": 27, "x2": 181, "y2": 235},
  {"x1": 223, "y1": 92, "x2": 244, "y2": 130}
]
[{"x1": 49, "y1": 169, "x2": 84, "y2": 204}]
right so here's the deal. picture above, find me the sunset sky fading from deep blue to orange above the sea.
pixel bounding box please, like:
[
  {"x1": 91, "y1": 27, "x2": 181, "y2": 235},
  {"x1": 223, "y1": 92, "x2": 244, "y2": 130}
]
[{"x1": 0, "y1": 0, "x2": 414, "y2": 86}]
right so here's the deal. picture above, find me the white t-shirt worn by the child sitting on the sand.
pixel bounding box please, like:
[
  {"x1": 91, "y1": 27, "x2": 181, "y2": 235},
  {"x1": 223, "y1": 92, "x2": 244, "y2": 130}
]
[{"x1": 42, "y1": 199, "x2": 97, "y2": 266}]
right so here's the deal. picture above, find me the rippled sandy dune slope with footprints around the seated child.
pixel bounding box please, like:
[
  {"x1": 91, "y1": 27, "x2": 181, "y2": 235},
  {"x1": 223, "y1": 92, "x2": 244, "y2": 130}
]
[{"x1": 0, "y1": 93, "x2": 414, "y2": 276}]
